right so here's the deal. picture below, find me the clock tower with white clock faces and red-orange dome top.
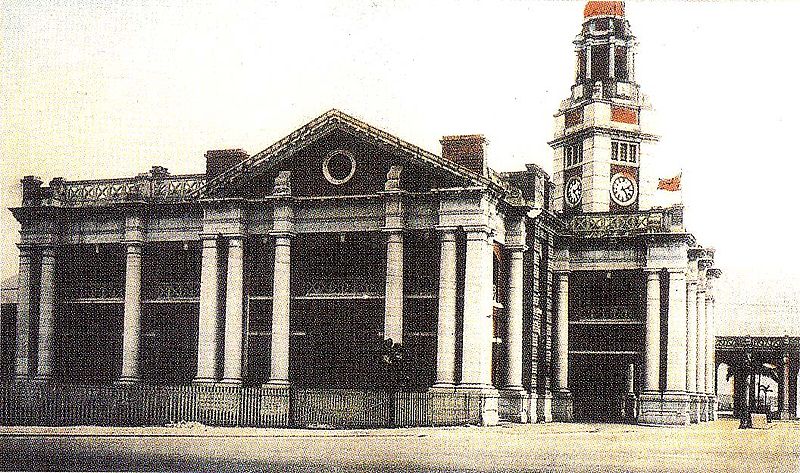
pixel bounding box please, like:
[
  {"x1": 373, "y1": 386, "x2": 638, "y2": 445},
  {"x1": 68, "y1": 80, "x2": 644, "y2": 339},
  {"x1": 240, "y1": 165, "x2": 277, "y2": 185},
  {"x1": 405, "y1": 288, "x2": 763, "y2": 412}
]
[{"x1": 549, "y1": 1, "x2": 658, "y2": 213}]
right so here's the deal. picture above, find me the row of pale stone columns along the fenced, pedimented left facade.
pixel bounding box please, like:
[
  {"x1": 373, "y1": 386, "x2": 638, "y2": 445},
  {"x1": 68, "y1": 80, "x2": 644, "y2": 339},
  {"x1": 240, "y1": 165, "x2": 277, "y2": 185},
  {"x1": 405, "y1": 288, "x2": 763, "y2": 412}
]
[{"x1": 15, "y1": 221, "x2": 526, "y2": 391}]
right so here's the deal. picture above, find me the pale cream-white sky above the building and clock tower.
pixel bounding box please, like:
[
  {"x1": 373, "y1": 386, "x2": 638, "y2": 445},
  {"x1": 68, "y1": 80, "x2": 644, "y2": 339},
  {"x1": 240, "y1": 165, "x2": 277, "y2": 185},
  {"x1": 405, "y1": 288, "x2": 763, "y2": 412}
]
[{"x1": 0, "y1": 0, "x2": 800, "y2": 335}]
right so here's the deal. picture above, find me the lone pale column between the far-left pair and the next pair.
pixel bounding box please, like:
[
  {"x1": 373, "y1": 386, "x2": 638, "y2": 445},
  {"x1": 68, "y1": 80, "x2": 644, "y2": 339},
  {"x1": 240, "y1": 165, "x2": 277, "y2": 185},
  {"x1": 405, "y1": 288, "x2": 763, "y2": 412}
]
[{"x1": 119, "y1": 242, "x2": 142, "y2": 383}]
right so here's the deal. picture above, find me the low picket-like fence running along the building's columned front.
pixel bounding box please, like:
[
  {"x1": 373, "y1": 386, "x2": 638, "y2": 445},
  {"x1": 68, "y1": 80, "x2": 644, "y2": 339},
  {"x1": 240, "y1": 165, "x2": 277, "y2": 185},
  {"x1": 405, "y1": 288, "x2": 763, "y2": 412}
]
[{"x1": 0, "y1": 382, "x2": 482, "y2": 428}]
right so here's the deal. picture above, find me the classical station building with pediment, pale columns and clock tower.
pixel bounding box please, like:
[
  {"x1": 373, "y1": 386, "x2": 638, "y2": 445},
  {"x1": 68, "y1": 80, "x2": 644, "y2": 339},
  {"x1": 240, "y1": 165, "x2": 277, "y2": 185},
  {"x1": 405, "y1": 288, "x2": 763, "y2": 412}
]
[{"x1": 0, "y1": 1, "x2": 720, "y2": 425}]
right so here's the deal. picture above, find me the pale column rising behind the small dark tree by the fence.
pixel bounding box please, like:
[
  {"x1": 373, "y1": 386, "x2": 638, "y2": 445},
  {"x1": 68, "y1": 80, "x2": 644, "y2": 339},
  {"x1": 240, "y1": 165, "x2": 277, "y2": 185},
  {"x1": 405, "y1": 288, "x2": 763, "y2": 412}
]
[{"x1": 383, "y1": 230, "x2": 403, "y2": 343}]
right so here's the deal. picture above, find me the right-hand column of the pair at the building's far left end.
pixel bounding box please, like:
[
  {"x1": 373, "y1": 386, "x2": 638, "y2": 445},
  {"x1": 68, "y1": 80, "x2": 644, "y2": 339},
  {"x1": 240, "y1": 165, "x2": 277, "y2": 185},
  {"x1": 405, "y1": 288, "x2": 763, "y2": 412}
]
[{"x1": 36, "y1": 246, "x2": 56, "y2": 381}]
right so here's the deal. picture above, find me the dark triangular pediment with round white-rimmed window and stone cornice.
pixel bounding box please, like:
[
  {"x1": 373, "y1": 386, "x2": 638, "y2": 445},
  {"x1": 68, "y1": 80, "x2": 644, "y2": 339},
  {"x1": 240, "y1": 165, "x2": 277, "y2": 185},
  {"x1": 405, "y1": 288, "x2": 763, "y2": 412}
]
[{"x1": 197, "y1": 109, "x2": 496, "y2": 198}]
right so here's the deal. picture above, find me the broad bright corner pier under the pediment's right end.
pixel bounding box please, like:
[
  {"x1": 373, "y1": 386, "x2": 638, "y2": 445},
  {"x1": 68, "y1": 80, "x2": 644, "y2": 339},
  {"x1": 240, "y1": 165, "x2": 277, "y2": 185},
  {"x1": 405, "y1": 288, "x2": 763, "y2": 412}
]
[{"x1": 461, "y1": 228, "x2": 491, "y2": 388}]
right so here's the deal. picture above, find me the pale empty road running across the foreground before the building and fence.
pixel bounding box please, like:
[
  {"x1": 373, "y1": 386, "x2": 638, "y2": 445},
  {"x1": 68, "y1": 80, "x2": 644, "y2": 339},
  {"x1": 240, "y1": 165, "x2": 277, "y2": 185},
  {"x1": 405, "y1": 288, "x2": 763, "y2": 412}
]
[{"x1": 0, "y1": 420, "x2": 800, "y2": 473}]
